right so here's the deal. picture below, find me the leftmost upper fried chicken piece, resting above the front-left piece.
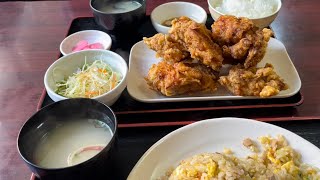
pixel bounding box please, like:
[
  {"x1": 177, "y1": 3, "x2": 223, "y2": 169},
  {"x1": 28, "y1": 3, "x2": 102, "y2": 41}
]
[{"x1": 143, "y1": 33, "x2": 190, "y2": 62}]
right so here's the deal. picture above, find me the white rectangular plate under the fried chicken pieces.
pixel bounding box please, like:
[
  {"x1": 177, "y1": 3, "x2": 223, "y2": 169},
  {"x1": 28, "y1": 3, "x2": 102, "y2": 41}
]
[{"x1": 127, "y1": 38, "x2": 301, "y2": 103}]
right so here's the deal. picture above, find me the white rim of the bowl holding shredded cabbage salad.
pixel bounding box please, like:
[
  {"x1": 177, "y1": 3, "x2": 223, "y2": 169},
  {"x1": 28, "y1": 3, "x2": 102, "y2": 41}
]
[{"x1": 44, "y1": 49, "x2": 128, "y2": 100}]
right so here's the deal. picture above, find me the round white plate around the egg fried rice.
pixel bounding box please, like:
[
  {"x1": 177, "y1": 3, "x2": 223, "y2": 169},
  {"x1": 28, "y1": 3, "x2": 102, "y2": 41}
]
[{"x1": 127, "y1": 118, "x2": 320, "y2": 180}]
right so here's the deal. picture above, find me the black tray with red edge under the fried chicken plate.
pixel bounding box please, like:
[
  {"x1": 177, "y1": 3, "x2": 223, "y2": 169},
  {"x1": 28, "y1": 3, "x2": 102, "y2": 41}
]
[{"x1": 37, "y1": 16, "x2": 303, "y2": 127}]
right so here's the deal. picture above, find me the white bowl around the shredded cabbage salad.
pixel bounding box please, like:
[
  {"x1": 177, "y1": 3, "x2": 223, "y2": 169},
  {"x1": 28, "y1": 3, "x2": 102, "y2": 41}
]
[{"x1": 44, "y1": 49, "x2": 128, "y2": 106}]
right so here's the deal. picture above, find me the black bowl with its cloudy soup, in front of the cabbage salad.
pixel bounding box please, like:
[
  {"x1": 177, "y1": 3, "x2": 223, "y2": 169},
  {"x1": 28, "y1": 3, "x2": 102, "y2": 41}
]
[{"x1": 17, "y1": 98, "x2": 117, "y2": 179}]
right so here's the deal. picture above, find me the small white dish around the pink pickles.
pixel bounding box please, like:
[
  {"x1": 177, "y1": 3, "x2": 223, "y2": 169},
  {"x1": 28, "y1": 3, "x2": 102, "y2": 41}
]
[{"x1": 60, "y1": 30, "x2": 112, "y2": 56}]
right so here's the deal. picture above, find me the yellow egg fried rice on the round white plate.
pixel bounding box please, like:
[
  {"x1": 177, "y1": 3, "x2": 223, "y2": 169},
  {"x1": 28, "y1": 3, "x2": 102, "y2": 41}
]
[{"x1": 165, "y1": 135, "x2": 320, "y2": 180}]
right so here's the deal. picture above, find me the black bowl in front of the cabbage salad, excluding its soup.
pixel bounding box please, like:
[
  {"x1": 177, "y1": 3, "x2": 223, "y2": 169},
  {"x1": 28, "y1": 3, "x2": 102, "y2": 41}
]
[{"x1": 17, "y1": 98, "x2": 117, "y2": 180}]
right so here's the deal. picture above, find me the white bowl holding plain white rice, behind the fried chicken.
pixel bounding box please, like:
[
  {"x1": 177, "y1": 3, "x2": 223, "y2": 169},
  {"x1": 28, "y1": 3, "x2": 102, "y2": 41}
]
[{"x1": 208, "y1": 0, "x2": 282, "y2": 28}]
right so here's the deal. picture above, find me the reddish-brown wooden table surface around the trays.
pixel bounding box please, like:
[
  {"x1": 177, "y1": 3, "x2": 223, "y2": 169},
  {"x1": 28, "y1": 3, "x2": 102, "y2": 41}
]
[{"x1": 0, "y1": 0, "x2": 320, "y2": 180}]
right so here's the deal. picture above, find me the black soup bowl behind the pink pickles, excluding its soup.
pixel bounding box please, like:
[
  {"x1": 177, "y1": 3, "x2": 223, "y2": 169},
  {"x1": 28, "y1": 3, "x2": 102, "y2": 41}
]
[{"x1": 90, "y1": 0, "x2": 146, "y2": 34}]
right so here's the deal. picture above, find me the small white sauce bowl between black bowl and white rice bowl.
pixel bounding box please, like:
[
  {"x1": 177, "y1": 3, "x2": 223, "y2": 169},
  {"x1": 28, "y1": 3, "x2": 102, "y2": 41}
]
[{"x1": 150, "y1": 2, "x2": 207, "y2": 34}]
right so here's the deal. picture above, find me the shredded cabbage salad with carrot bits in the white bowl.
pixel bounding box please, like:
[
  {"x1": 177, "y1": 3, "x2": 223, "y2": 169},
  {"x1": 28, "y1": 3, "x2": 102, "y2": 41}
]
[{"x1": 53, "y1": 60, "x2": 122, "y2": 98}]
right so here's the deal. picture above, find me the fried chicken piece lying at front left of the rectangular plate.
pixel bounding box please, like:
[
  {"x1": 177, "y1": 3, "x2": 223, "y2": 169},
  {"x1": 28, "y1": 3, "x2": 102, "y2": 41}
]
[{"x1": 145, "y1": 61, "x2": 217, "y2": 96}]
